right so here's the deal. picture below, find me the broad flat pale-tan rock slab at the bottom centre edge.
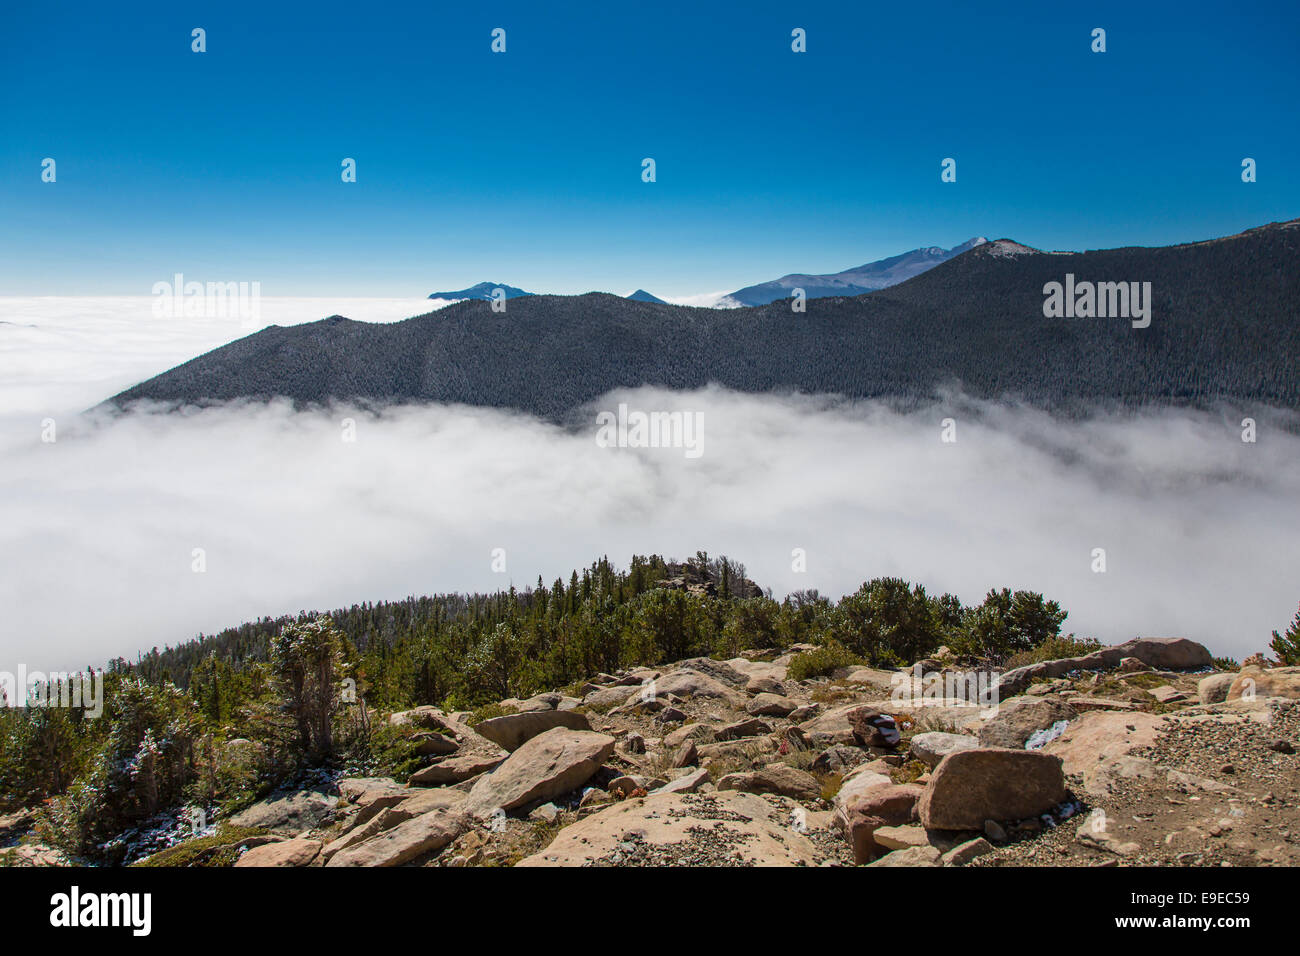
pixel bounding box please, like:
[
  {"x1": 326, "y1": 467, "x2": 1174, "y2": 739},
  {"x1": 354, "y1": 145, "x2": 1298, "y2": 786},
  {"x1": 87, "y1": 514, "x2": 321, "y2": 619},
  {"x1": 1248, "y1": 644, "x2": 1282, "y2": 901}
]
[{"x1": 519, "y1": 791, "x2": 816, "y2": 866}]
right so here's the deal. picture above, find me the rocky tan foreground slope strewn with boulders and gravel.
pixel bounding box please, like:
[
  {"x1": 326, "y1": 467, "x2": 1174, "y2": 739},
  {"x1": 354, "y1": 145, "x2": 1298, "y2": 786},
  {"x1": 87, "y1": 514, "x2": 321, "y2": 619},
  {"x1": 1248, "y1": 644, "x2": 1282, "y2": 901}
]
[{"x1": 5, "y1": 639, "x2": 1300, "y2": 866}]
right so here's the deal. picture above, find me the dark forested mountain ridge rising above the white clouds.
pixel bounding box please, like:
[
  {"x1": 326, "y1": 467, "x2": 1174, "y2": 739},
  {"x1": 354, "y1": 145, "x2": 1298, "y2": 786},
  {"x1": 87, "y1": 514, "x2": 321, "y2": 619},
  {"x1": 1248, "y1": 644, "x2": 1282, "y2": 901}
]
[{"x1": 111, "y1": 220, "x2": 1300, "y2": 420}]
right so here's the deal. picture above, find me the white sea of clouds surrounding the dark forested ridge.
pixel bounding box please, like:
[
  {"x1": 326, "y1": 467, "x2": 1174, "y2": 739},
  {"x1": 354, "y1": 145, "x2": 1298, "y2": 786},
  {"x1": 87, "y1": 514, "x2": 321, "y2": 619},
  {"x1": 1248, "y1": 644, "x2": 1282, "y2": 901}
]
[{"x1": 0, "y1": 298, "x2": 1300, "y2": 671}]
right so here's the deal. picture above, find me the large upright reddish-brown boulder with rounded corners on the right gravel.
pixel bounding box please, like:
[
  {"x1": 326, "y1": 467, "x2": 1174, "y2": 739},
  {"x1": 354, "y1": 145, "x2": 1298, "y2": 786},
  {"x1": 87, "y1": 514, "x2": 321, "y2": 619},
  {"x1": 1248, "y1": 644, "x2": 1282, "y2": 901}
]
[{"x1": 917, "y1": 748, "x2": 1066, "y2": 830}]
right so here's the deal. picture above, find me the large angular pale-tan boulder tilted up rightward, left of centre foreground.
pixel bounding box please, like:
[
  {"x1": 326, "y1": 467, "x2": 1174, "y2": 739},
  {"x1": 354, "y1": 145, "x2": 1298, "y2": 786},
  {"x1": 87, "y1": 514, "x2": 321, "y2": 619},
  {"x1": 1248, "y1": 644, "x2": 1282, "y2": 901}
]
[{"x1": 465, "y1": 727, "x2": 615, "y2": 819}]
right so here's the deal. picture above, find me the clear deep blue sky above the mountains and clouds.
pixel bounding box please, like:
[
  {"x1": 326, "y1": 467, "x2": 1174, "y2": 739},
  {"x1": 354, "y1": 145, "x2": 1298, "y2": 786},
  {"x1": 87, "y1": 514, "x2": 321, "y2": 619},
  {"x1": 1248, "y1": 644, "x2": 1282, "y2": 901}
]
[{"x1": 0, "y1": 1, "x2": 1300, "y2": 297}]
